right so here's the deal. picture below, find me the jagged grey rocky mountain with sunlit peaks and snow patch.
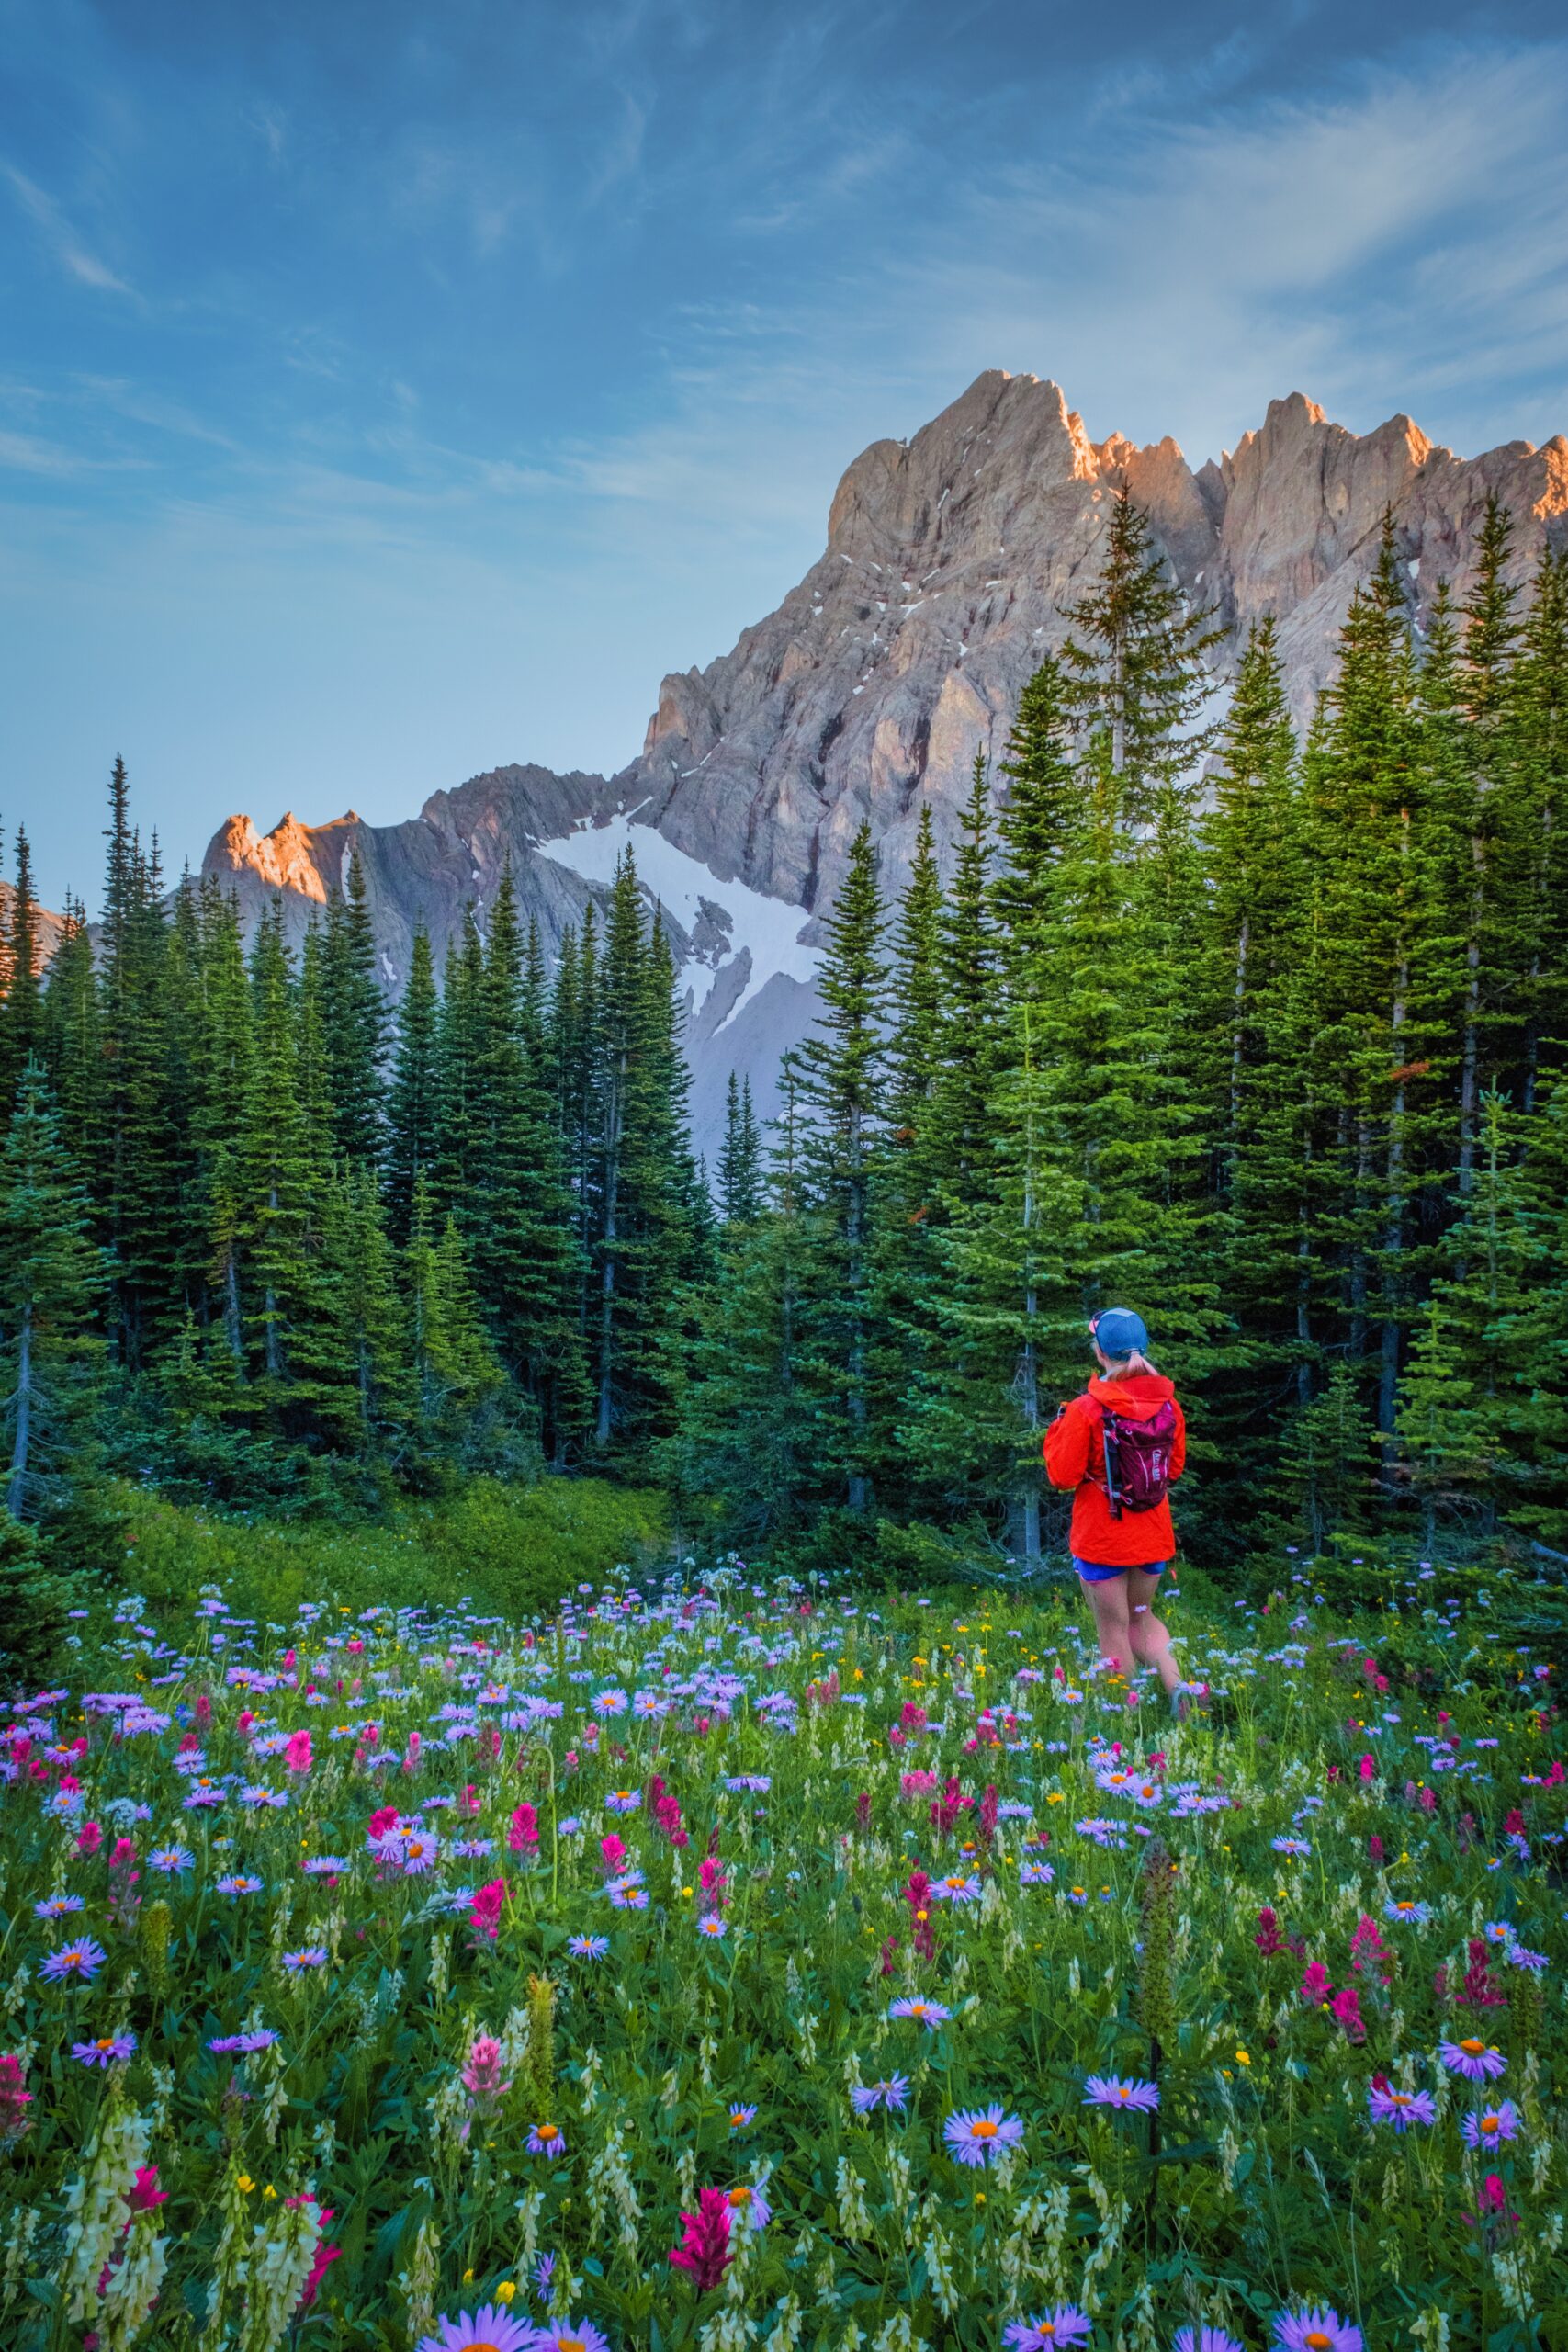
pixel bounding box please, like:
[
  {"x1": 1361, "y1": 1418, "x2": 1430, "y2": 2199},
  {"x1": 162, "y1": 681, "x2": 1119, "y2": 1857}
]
[{"x1": 205, "y1": 369, "x2": 1568, "y2": 1146}]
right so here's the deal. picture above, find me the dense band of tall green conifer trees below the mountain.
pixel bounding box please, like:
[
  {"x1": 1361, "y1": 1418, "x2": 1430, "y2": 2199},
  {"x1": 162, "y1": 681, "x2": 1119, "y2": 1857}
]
[{"x1": 0, "y1": 489, "x2": 1568, "y2": 1589}]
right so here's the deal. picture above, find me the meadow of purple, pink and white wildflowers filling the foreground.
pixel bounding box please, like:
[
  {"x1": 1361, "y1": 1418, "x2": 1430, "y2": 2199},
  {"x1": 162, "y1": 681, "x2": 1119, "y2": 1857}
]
[{"x1": 0, "y1": 1562, "x2": 1568, "y2": 2352}]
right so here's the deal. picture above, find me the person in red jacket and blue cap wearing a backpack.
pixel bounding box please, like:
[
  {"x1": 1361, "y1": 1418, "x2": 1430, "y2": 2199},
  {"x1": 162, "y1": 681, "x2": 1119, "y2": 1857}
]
[{"x1": 1043, "y1": 1307, "x2": 1187, "y2": 1717}]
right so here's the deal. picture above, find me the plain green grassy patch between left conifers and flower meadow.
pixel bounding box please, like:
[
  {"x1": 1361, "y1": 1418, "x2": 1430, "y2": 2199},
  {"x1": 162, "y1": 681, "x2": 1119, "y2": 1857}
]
[{"x1": 101, "y1": 1477, "x2": 668, "y2": 1623}]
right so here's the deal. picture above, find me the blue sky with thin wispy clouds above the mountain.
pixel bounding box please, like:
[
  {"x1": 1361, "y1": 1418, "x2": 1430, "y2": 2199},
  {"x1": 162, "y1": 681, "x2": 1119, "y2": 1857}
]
[{"x1": 0, "y1": 0, "x2": 1568, "y2": 903}]
